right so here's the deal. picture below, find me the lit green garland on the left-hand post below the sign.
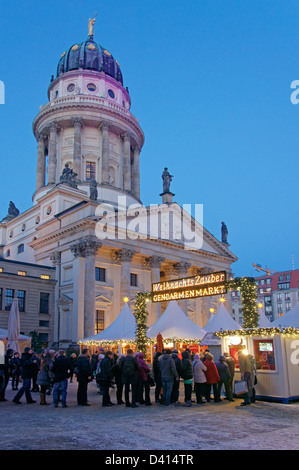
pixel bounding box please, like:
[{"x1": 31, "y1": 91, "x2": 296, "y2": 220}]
[{"x1": 134, "y1": 292, "x2": 151, "y2": 357}]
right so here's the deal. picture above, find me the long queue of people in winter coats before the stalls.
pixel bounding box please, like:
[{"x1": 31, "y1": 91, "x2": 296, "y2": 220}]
[{"x1": 0, "y1": 347, "x2": 254, "y2": 408}]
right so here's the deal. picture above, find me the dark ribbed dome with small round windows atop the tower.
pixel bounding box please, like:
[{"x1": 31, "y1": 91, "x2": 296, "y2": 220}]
[{"x1": 57, "y1": 36, "x2": 123, "y2": 85}]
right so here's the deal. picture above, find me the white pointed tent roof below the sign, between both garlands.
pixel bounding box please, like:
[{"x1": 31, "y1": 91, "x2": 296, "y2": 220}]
[{"x1": 147, "y1": 300, "x2": 206, "y2": 342}]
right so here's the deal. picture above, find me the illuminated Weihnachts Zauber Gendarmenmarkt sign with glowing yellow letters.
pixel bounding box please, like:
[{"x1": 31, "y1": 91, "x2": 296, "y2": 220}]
[{"x1": 152, "y1": 271, "x2": 227, "y2": 302}]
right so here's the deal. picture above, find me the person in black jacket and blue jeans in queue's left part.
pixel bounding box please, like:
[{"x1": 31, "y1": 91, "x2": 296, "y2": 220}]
[{"x1": 52, "y1": 349, "x2": 71, "y2": 408}]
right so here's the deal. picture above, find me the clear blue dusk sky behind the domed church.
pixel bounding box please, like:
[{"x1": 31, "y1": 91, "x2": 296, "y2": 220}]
[{"x1": 0, "y1": 0, "x2": 299, "y2": 276}]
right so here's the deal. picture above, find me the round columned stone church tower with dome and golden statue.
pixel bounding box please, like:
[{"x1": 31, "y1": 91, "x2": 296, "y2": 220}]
[{"x1": 33, "y1": 19, "x2": 144, "y2": 206}]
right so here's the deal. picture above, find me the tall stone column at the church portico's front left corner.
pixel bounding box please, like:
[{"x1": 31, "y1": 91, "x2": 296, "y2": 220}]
[{"x1": 70, "y1": 237, "x2": 102, "y2": 338}]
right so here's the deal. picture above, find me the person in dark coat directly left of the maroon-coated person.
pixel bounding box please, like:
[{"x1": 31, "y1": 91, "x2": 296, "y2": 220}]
[{"x1": 119, "y1": 349, "x2": 139, "y2": 408}]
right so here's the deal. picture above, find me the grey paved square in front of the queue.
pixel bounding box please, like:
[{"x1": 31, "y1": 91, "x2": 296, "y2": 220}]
[{"x1": 0, "y1": 382, "x2": 299, "y2": 451}]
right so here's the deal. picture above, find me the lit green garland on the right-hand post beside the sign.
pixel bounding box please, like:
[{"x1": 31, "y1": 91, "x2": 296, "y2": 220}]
[{"x1": 227, "y1": 277, "x2": 259, "y2": 328}]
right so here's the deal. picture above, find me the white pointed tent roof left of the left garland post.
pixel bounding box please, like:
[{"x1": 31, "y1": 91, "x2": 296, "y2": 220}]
[{"x1": 78, "y1": 303, "x2": 137, "y2": 345}]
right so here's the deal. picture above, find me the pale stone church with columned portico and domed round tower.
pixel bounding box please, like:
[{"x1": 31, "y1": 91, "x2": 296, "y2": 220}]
[{"x1": 0, "y1": 20, "x2": 237, "y2": 347}]
